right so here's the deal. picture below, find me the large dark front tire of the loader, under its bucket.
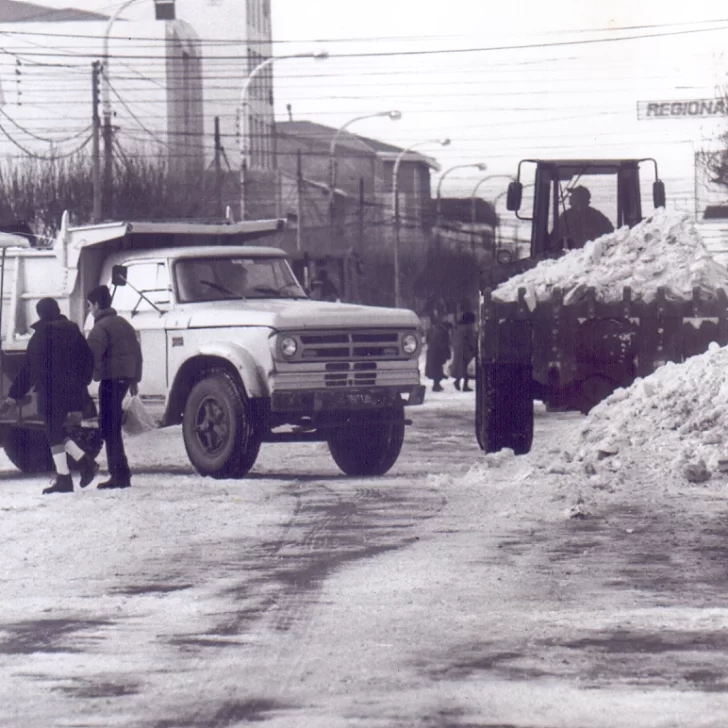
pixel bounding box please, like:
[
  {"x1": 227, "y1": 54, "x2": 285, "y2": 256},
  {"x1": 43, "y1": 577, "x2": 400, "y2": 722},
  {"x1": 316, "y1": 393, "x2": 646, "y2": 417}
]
[{"x1": 475, "y1": 363, "x2": 533, "y2": 455}]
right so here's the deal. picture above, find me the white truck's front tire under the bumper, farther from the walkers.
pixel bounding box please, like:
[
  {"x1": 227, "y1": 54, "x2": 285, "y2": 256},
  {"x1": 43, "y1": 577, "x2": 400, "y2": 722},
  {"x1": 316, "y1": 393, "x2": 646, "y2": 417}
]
[{"x1": 327, "y1": 403, "x2": 404, "y2": 475}]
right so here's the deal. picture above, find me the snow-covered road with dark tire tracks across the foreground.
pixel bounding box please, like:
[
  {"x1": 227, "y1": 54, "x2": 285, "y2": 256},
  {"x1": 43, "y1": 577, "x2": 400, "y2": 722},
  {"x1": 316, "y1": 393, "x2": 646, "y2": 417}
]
[{"x1": 0, "y1": 392, "x2": 728, "y2": 728}]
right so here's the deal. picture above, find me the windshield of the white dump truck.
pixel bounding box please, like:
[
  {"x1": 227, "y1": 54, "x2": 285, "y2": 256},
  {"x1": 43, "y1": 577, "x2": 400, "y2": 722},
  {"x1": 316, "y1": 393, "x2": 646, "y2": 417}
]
[{"x1": 174, "y1": 257, "x2": 308, "y2": 303}]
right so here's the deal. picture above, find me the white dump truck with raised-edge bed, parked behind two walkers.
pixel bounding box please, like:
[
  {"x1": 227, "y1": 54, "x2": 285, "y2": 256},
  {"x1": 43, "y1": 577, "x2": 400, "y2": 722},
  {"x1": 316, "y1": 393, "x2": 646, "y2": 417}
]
[{"x1": 0, "y1": 214, "x2": 424, "y2": 478}]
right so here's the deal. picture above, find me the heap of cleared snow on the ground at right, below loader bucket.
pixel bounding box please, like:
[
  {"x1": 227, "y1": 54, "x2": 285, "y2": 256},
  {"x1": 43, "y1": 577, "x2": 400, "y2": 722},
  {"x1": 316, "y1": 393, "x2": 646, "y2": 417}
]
[{"x1": 546, "y1": 343, "x2": 728, "y2": 498}]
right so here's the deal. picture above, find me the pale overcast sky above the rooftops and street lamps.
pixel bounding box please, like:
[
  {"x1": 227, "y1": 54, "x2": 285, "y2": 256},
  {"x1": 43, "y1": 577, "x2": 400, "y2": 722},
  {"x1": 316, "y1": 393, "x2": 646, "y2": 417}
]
[{"x1": 34, "y1": 0, "x2": 728, "y2": 211}]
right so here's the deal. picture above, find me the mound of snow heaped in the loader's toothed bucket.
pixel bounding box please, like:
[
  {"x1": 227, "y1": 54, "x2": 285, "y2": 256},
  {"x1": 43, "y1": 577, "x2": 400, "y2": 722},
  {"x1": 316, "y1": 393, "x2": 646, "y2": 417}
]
[{"x1": 493, "y1": 208, "x2": 728, "y2": 307}]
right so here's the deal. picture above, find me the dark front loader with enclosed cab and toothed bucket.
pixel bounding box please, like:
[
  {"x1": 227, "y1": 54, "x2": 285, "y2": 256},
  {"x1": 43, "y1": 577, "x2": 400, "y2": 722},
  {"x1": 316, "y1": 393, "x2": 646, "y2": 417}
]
[{"x1": 475, "y1": 159, "x2": 728, "y2": 454}]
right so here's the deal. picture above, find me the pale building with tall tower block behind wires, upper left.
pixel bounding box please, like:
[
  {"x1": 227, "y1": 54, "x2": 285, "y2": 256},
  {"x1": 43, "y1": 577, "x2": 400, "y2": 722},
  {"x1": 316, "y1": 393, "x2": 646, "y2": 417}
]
[{"x1": 0, "y1": 0, "x2": 275, "y2": 217}]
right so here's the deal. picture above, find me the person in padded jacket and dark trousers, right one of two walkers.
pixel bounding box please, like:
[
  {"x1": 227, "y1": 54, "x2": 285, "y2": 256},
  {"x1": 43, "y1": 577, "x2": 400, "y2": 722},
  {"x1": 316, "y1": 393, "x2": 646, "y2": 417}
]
[{"x1": 86, "y1": 286, "x2": 142, "y2": 490}]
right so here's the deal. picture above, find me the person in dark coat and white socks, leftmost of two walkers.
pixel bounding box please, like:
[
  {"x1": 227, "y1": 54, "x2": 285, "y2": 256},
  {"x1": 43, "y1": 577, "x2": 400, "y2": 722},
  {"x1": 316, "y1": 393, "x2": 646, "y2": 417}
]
[{"x1": 8, "y1": 298, "x2": 99, "y2": 494}]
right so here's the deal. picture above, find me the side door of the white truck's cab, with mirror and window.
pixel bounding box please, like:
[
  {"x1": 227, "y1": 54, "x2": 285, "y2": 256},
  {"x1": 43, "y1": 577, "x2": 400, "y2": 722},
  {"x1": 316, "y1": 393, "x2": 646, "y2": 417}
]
[{"x1": 109, "y1": 260, "x2": 171, "y2": 397}]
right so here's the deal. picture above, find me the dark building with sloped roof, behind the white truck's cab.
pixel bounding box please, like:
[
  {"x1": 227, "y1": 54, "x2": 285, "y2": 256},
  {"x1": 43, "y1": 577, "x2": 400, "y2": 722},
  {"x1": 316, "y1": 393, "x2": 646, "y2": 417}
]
[{"x1": 276, "y1": 121, "x2": 439, "y2": 309}]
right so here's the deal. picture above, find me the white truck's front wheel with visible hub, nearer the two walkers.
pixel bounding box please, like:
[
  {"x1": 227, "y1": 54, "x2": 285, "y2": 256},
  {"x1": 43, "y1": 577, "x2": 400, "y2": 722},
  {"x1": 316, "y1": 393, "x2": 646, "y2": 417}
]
[{"x1": 182, "y1": 372, "x2": 262, "y2": 478}]
